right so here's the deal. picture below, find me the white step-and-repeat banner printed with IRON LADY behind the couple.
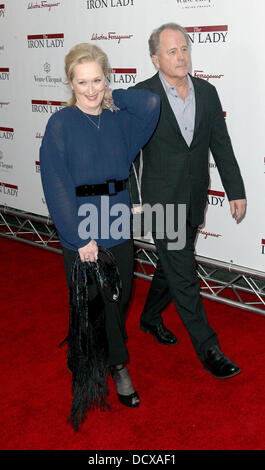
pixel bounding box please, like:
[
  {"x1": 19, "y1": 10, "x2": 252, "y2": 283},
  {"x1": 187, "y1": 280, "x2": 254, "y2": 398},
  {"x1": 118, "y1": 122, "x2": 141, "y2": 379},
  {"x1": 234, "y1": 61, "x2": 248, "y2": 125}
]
[{"x1": 0, "y1": 0, "x2": 265, "y2": 271}]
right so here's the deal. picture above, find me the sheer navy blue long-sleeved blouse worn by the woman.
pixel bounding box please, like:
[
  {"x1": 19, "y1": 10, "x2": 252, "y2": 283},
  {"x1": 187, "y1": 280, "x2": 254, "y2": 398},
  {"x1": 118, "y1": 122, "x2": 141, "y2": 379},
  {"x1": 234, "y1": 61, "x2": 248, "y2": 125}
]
[{"x1": 40, "y1": 89, "x2": 160, "y2": 251}]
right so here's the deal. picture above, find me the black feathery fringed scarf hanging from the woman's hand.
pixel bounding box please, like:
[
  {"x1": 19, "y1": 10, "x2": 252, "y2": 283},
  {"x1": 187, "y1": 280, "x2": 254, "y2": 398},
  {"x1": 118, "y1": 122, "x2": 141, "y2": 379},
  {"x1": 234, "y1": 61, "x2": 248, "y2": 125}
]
[{"x1": 67, "y1": 248, "x2": 121, "y2": 431}]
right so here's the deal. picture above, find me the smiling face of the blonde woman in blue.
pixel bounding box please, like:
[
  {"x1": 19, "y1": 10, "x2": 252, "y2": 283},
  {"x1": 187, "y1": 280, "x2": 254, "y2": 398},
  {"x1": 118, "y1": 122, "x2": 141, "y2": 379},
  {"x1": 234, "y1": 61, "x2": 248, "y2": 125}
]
[{"x1": 71, "y1": 62, "x2": 106, "y2": 114}]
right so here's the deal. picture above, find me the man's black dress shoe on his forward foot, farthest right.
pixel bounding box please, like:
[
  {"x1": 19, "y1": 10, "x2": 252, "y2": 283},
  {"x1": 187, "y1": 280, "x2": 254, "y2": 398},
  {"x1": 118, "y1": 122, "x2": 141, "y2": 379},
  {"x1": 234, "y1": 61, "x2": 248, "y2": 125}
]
[{"x1": 202, "y1": 346, "x2": 240, "y2": 379}]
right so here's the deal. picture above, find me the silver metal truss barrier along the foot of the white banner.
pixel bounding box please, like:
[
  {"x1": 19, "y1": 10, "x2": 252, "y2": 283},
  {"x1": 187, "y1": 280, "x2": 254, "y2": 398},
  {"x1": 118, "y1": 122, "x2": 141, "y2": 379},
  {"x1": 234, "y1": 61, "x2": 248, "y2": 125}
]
[{"x1": 0, "y1": 205, "x2": 265, "y2": 316}]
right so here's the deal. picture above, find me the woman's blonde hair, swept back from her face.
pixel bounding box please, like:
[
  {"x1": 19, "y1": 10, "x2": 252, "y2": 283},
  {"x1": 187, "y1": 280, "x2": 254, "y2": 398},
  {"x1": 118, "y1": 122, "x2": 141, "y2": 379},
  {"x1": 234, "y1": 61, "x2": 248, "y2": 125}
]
[{"x1": 65, "y1": 42, "x2": 109, "y2": 106}]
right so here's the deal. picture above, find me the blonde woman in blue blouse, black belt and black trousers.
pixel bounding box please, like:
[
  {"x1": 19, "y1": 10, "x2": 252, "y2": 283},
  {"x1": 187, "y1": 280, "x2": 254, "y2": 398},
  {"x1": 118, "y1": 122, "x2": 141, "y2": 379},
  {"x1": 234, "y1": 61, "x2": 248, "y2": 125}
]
[{"x1": 40, "y1": 43, "x2": 159, "y2": 428}]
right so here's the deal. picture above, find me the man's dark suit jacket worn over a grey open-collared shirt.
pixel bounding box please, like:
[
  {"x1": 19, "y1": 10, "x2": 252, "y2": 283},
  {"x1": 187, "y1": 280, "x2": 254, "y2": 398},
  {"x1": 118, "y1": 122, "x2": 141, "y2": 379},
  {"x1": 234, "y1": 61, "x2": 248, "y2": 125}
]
[{"x1": 129, "y1": 73, "x2": 245, "y2": 227}]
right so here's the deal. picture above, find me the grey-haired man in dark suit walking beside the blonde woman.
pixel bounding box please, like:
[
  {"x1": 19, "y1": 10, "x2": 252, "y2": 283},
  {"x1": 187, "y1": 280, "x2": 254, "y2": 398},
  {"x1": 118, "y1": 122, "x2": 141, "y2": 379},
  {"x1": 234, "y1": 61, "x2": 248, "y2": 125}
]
[{"x1": 131, "y1": 23, "x2": 246, "y2": 378}]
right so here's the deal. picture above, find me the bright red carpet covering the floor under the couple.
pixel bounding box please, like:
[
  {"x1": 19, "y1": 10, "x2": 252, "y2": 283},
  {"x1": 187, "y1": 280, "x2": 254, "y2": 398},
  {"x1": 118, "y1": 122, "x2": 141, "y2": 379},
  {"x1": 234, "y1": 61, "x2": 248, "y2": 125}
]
[{"x1": 0, "y1": 238, "x2": 265, "y2": 450}]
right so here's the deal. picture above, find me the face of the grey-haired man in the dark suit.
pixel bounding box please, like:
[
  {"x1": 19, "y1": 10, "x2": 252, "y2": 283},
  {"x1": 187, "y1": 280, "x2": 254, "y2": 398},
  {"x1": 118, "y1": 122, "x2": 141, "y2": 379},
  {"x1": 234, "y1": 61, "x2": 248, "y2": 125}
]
[{"x1": 152, "y1": 29, "x2": 190, "y2": 85}]
